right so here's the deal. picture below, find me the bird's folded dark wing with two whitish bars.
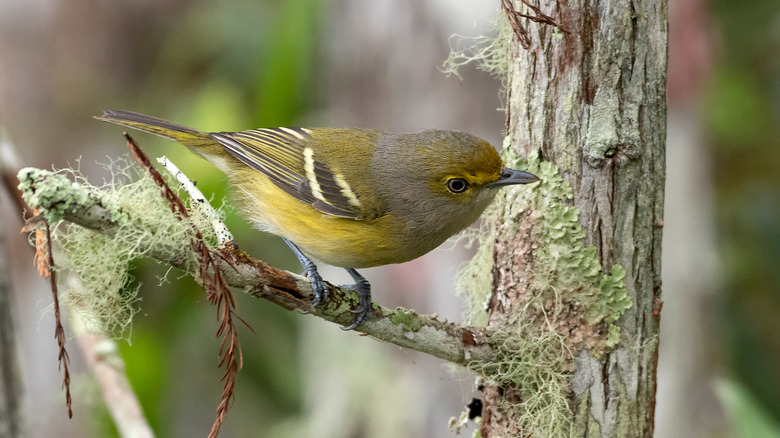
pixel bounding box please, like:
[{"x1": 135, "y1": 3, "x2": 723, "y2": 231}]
[{"x1": 211, "y1": 128, "x2": 365, "y2": 219}]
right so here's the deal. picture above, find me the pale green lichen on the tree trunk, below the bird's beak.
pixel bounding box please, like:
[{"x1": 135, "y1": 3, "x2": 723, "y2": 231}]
[{"x1": 457, "y1": 136, "x2": 631, "y2": 437}]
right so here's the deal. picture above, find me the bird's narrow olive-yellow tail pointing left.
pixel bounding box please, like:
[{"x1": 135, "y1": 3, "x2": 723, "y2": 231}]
[{"x1": 95, "y1": 110, "x2": 217, "y2": 148}]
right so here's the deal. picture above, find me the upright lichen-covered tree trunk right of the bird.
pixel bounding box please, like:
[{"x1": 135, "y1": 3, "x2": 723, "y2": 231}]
[{"x1": 481, "y1": 0, "x2": 667, "y2": 438}]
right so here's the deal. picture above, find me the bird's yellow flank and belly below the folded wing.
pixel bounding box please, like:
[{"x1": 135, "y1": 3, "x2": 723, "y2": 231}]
[{"x1": 230, "y1": 164, "x2": 406, "y2": 268}]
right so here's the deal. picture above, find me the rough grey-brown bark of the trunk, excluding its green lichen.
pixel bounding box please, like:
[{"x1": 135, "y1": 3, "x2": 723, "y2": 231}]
[{"x1": 482, "y1": 0, "x2": 667, "y2": 438}]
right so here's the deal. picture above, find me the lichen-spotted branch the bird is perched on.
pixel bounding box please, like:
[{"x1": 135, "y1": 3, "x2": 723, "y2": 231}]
[{"x1": 18, "y1": 168, "x2": 501, "y2": 366}]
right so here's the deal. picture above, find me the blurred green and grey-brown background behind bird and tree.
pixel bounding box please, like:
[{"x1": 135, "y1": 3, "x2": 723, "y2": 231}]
[{"x1": 0, "y1": 0, "x2": 780, "y2": 438}]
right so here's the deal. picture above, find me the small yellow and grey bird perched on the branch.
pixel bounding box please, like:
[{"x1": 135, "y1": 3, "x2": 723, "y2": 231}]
[{"x1": 97, "y1": 110, "x2": 538, "y2": 329}]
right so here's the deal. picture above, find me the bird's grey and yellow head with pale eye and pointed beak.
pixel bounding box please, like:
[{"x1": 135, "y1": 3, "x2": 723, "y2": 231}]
[{"x1": 374, "y1": 130, "x2": 539, "y2": 237}]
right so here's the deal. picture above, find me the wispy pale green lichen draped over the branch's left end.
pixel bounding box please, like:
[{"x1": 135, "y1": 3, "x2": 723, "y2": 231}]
[{"x1": 19, "y1": 160, "x2": 216, "y2": 338}]
